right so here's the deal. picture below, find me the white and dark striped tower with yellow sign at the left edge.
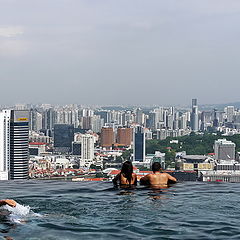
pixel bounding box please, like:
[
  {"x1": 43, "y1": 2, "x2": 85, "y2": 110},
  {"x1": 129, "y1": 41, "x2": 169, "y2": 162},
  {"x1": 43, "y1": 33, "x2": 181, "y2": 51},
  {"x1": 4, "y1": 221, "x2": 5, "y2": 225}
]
[{"x1": 0, "y1": 110, "x2": 29, "y2": 180}]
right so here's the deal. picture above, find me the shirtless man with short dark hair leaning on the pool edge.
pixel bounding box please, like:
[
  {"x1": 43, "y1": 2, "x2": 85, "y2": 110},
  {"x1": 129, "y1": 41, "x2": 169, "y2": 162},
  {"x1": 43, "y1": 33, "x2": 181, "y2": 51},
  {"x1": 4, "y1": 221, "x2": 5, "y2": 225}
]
[{"x1": 140, "y1": 162, "x2": 177, "y2": 187}]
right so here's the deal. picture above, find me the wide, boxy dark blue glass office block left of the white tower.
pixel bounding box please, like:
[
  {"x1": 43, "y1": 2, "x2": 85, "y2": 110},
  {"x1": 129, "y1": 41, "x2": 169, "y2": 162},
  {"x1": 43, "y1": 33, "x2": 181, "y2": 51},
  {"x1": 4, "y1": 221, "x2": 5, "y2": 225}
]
[{"x1": 54, "y1": 124, "x2": 74, "y2": 153}]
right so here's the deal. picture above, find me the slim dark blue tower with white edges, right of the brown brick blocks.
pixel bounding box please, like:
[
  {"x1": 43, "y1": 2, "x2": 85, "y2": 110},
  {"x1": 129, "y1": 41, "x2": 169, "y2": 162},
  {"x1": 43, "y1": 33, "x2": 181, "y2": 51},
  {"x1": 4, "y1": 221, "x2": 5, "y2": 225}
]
[{"x1": 133, "y1": 126, "x2": 145, "y2": 162}]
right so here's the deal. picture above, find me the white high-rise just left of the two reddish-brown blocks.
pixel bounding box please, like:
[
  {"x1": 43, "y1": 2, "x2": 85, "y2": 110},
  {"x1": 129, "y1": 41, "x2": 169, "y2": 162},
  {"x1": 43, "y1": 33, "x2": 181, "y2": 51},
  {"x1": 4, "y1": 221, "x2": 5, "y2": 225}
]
[{"x1": 81, "y1": 134, "x2": 94, "y2": 167}]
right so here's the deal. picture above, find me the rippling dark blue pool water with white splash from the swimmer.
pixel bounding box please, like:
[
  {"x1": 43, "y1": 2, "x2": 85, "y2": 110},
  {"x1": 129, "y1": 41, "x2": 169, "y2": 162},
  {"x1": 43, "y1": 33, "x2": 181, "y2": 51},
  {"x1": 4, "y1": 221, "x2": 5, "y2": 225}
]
[{"x1": 0, "y1": 181, "x2": 240, "y2": 240}]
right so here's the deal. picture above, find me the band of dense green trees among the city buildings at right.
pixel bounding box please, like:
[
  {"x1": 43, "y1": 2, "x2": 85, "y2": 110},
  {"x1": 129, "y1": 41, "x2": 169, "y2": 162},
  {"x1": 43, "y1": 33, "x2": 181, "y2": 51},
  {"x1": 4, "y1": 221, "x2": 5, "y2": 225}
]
[{"x1": 146, "y1": 133, "x2": 240, "y2": 157}]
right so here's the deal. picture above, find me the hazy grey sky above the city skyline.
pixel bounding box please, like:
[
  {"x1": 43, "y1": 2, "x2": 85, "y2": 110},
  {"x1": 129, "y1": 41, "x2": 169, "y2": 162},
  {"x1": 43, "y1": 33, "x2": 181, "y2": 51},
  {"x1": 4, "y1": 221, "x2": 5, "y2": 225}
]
[{"x1": 0, "y1": 0, "x2": 240, "y2": 105}]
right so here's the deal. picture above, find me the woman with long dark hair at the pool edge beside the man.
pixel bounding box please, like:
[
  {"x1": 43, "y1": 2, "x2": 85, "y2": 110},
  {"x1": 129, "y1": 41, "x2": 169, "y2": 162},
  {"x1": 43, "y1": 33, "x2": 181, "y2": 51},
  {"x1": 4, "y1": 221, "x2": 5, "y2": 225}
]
[{"x1": 113, "y1": 161, "x2": 137, "y2": 186}]
